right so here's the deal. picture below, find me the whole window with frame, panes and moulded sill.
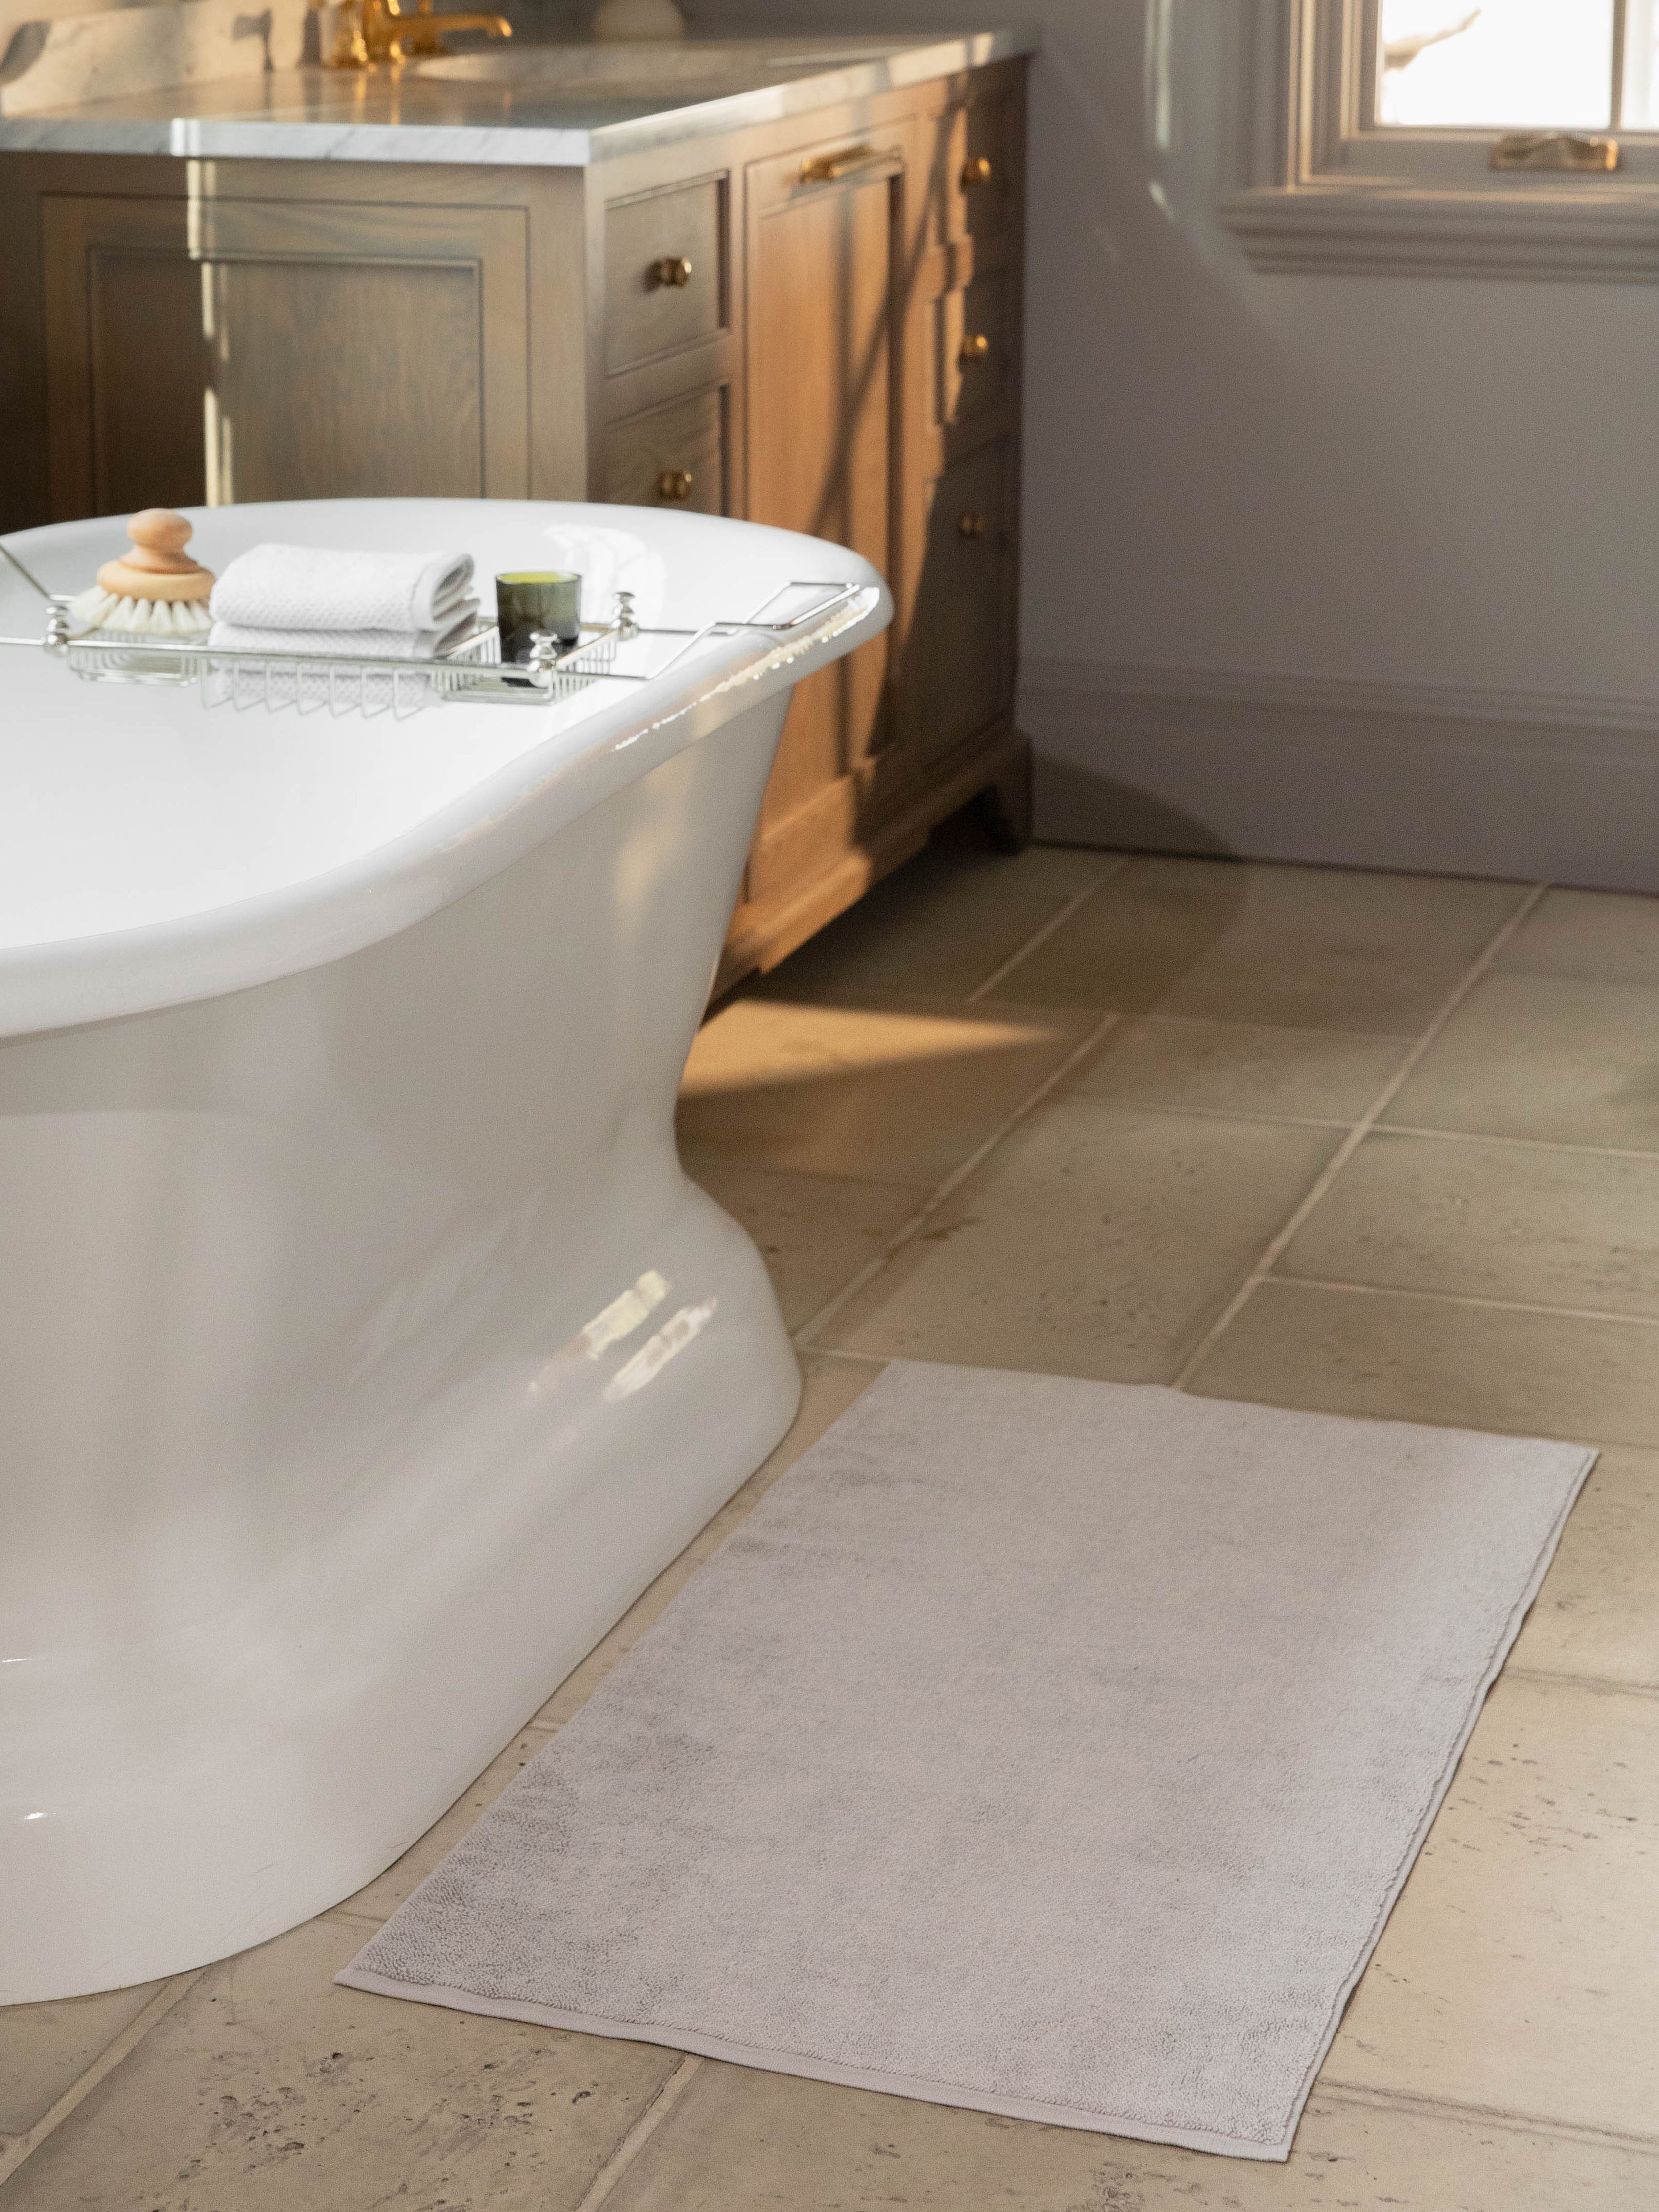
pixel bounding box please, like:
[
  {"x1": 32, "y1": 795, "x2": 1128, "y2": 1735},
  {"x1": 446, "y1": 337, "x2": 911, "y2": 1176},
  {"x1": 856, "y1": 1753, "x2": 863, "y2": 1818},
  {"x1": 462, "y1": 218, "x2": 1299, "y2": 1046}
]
[{"x1": 1223, "y1": 0, "x2": 1659, "y2": 281}]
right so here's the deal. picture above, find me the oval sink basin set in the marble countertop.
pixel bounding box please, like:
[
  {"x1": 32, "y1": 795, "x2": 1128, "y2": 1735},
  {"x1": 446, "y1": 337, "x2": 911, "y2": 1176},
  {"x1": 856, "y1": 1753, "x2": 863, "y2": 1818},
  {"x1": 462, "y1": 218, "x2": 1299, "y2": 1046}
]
[{"x1": 407, "y1": 37, "x2": 927, "y2": 99}]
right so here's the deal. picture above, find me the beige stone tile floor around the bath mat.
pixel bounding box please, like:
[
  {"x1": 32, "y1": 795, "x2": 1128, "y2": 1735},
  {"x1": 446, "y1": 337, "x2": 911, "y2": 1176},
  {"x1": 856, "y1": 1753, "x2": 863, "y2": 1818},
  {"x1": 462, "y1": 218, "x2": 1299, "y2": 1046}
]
[{"x1": 0, "y1": 845, "x2": 1659, "y2": 2212}]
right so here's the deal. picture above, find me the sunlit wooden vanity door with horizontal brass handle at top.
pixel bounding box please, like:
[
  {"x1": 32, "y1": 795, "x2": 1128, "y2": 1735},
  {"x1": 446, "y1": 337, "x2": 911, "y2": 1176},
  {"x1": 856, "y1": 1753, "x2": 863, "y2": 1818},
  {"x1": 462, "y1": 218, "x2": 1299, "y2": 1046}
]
[{"x1": 748, "y1": 140, "x2": 900, "y2": 845}]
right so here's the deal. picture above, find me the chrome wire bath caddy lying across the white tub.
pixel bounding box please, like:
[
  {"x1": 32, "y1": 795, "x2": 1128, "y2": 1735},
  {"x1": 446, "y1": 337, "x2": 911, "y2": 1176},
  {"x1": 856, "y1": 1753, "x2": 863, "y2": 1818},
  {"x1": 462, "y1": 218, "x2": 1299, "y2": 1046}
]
[{"x1": 0, "y1": 544, "x2": 867, "y2": 719}]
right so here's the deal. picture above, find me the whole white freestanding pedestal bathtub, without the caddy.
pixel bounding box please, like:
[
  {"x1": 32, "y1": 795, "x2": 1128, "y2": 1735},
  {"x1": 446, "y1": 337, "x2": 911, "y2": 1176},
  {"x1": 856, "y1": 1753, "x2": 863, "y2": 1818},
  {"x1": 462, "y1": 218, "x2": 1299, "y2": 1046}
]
[{"x1": 0, "y1": 500, "x2": 889, "y2": 2002}]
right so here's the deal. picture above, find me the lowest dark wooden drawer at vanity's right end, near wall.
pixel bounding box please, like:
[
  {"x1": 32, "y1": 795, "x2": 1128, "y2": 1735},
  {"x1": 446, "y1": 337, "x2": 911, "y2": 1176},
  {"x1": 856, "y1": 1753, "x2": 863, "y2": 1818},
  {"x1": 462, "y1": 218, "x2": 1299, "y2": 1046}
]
[{"x1": 905, "y1": 440, "x2": 1015, "y2": 759}]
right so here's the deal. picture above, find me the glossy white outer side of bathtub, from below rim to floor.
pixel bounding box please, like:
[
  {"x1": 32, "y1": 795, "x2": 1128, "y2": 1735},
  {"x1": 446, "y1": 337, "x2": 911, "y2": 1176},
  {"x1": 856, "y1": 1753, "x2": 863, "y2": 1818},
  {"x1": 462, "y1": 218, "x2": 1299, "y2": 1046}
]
[{"x1": 0, "y1": 615, "x2": 836, "y2": 2004}]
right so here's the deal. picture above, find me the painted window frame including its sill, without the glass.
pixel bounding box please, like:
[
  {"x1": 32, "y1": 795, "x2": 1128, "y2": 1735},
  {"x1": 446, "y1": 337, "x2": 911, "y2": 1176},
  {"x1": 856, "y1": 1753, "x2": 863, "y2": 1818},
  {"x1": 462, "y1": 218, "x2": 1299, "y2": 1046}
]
[{"x1": 1221, "y1": 0, "x2": 1659, "y2": 283}]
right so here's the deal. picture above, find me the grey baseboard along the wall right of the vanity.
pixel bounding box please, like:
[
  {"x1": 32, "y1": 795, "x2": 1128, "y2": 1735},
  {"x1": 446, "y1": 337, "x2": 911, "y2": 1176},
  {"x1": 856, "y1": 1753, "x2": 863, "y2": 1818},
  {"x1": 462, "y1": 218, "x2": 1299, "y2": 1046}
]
[{"x1": 1020, "y1": 661, "x2": 1659, "y2": 891}]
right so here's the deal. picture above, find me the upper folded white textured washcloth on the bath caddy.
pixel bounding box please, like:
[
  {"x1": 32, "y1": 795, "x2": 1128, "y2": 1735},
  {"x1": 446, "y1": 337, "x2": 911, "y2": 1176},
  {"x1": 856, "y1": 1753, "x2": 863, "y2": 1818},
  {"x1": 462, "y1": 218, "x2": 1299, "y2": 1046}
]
[{"x1": 208, "y1": 547, "x2": 473, "y2": 650}]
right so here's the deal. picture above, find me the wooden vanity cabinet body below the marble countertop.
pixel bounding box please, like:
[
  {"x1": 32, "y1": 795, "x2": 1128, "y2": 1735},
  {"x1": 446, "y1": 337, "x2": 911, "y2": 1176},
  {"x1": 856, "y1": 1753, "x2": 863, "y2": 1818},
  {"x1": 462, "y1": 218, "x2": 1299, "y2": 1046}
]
[{"x1": 0, "y1": 62, "x2": 1026, "y2": 982}]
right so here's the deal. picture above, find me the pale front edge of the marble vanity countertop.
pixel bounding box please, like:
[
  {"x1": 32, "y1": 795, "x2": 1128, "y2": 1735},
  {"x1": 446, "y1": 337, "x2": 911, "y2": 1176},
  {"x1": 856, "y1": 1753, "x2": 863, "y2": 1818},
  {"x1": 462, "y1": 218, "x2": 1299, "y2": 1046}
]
[{"x1": 0, "y1": 27, "x2": 1040, "y2": 168}]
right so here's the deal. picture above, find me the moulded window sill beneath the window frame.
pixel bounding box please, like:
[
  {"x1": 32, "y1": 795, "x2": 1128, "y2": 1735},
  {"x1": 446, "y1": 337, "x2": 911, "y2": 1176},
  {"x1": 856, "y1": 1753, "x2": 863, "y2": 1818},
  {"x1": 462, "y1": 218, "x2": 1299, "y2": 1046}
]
[{"x1": 1221, "y1": 179, "x2": 1659, "y2": 283}]
